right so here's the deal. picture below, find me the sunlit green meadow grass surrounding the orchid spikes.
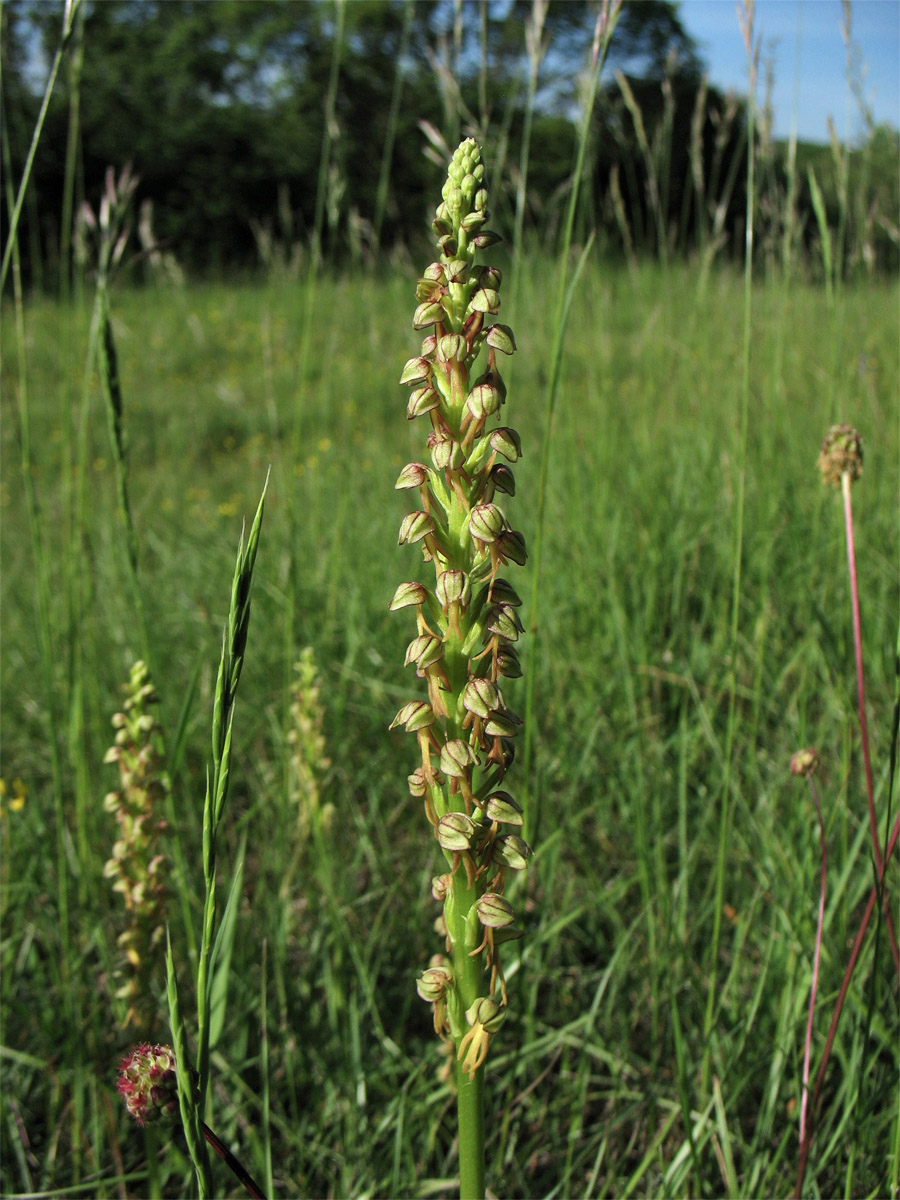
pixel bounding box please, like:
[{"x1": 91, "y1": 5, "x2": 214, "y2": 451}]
[{"x1": 0, "y1": 256, "x2": 900, "y2": 1196}]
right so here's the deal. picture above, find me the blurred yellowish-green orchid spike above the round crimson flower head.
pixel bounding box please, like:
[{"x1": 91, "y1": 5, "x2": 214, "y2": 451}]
[{"x1": 103, "y1": 662, "x2": 169, "y2": 1032}]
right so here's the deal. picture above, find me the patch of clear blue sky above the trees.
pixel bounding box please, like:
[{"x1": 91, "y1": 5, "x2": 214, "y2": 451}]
[{"x1": 678, "y1": 0, "x2": 900, "y2": 142}]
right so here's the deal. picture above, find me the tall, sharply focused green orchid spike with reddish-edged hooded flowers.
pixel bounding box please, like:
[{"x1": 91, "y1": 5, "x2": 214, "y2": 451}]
[{"x1": 391, "y1": 139, "x2": 530, "y2": 1196}]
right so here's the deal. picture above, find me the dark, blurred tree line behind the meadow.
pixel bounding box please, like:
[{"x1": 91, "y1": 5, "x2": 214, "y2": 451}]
[{"x1": 0, "y1": 0, "x2": 898, "y2": 283}]
